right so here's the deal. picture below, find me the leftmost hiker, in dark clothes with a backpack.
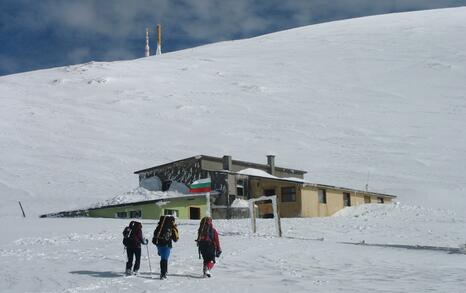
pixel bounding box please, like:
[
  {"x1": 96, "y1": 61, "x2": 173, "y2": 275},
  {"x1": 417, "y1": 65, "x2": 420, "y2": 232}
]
[{"x1": 123, "y1": 221, "x2": 149, "y2": 276}]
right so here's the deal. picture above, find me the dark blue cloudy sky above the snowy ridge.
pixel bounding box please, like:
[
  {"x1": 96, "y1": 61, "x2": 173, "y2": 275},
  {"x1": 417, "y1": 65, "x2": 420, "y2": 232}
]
[{"x1": 0, "y1": 0, "x2": 466, "y2": 75}]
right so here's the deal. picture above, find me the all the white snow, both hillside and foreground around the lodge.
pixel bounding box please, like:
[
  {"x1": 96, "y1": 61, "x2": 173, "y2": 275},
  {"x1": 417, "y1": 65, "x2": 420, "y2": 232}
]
[{"x1": 0, "y1": 7, "x2": 466, "y2": 292}]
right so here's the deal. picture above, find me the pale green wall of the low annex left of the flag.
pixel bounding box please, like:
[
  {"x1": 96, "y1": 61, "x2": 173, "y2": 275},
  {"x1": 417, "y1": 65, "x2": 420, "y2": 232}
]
[{"x1": 89, "y1": 196, "x2": 206, "y2": 219}]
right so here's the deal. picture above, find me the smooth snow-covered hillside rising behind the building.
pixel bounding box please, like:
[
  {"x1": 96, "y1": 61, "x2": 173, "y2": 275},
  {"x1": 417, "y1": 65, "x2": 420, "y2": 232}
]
[{"x1": 0, "y1": 8, "x2": 466, "y2": 216}]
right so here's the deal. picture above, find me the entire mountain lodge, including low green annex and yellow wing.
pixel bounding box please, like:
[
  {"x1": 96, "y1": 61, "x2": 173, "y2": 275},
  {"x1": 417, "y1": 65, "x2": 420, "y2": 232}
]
[{"x1": 42, "y1": 155, "x2": 396, "y2": 219}]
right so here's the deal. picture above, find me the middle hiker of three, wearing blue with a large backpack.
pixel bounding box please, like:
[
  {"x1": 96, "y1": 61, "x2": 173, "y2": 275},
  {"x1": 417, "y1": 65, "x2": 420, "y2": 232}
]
[{"x1": 152, "y1": 216, "x2": 179, "y2": 280}]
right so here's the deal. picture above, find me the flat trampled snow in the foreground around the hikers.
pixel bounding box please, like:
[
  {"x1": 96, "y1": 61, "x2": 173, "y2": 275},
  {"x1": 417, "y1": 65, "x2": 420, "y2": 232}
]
[{"x1": 0, "y1": 204, "x2": 466, "y2": 292}]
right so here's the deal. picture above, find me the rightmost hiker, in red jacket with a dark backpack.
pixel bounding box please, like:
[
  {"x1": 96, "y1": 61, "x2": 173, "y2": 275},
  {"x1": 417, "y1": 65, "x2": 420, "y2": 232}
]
[{"x1": 196, "y1": 217, "x2": 222, "y2": 278}]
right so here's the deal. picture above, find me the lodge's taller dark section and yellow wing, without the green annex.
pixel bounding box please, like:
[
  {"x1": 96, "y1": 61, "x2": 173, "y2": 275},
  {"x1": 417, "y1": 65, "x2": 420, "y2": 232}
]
[{"x1": 134, "y1": 155, "x2": 396, "y2": 218}]
